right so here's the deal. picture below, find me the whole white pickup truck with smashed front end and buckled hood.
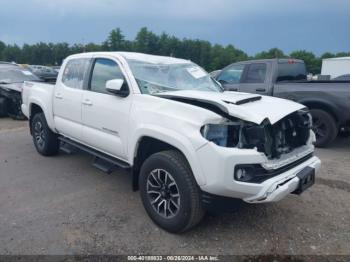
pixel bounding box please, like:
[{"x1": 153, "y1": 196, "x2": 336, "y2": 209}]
[{"x1": 22, "y1": 52, "x2": 320, "y2": 232}]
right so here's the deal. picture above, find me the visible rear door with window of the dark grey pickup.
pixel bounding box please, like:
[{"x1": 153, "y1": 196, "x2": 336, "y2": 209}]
[{"x1": 239, "y1": 62, "x2": 270, "y2": 95}]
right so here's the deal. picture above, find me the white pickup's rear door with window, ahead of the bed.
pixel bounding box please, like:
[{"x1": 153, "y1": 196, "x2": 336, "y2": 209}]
[{"x1": 53, "y1": 58, "x2": 90, "y2": 140}]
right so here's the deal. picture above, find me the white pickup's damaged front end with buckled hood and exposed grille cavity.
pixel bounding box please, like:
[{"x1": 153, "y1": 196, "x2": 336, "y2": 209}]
[{"x1": 161, "y1": 92, "x2": 315, "y2": 181}]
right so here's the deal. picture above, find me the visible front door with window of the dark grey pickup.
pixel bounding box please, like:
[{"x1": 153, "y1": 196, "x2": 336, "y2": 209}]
[{"x1": 216, "y1": 64, "x2": 245, "y2": 91}]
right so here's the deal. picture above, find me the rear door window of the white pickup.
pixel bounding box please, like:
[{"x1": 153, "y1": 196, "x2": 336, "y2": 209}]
[{"x1": 62, "y1": 58, "x2": 90, "y2": 89}]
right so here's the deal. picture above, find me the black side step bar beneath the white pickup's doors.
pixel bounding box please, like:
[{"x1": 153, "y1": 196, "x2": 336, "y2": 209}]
[{"x1": 58, "y1": 136, "x2": 131, "y2": 174}]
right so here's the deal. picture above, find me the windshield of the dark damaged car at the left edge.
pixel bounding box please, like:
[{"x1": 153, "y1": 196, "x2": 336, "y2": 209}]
[{"x1": 0, "y1": 68, "x2": 41, "y2": 84}]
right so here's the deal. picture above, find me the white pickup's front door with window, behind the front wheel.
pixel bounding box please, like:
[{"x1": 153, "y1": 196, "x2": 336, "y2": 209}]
[{"x1": 82, "y1": 56, "x2": 132, "y2": 159}]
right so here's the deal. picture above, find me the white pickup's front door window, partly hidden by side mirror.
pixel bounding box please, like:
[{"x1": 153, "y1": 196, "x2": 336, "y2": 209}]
[{"x1": 90, "y1": 58, "x2": 124, "y2": 94}]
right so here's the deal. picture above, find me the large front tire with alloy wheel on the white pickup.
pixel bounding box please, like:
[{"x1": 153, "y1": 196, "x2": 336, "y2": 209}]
[{"x1": 139, "y1": 150, "x2": 204, "y2": 233}]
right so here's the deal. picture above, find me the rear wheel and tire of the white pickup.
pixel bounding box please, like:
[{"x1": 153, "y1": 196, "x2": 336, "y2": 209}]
[{"x1": 31, "y1": 113, "x2": 60, "y2": 156}]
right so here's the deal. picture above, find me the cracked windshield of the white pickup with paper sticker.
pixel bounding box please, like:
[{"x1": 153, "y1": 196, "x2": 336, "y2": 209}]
[{"x1": 128, "y1": 60, "x2": 222, "y2": 94}]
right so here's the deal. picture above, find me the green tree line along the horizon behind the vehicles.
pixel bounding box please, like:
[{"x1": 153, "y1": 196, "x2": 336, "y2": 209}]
[{"x1": 0, "y1": 27, "x2": 350, "y2": 74}]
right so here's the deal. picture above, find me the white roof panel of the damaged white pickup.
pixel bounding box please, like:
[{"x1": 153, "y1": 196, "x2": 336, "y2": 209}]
[{"x1": 69, "y1": 52, "x2": 190, "y2": 64}]
